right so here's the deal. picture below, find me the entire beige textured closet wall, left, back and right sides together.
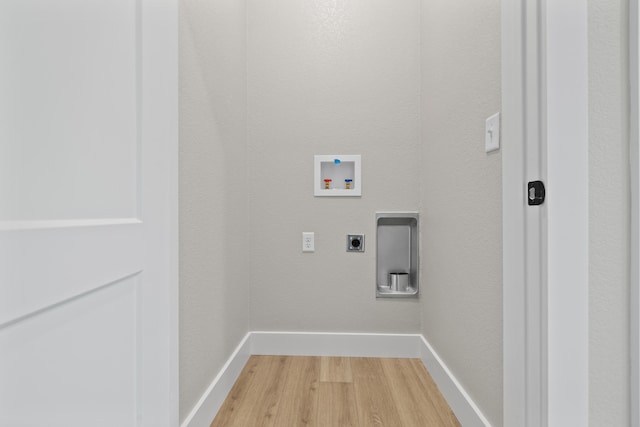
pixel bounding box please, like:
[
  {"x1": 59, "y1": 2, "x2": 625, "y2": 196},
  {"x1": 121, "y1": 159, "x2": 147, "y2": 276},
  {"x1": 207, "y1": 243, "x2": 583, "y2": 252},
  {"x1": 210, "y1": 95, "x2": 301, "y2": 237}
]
[{"x1": 180, "y1": 0, "x2": 502, "y2": 425}]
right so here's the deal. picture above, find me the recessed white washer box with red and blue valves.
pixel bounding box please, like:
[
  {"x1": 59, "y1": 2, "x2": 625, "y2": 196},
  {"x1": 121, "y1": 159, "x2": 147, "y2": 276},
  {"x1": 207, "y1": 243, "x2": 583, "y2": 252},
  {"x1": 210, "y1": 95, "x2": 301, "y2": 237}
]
[{"x1": 313, "y1": 154, "x2": 362, "y2": 197}]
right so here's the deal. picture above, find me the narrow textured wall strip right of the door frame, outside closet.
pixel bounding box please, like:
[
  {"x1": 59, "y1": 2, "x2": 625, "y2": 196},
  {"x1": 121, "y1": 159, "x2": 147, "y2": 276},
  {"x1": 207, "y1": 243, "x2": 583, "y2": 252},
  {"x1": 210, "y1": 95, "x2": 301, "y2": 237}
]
[{"x1": 589, "y1": 0, "x2": 630, "y2": 426}]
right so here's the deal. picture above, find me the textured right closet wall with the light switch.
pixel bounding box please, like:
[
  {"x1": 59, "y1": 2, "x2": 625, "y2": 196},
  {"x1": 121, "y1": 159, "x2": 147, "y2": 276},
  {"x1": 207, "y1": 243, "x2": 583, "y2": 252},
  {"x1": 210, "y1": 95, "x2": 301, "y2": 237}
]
[{"x1": 421, "y1": 0, "x2": 502, "y2": 426}]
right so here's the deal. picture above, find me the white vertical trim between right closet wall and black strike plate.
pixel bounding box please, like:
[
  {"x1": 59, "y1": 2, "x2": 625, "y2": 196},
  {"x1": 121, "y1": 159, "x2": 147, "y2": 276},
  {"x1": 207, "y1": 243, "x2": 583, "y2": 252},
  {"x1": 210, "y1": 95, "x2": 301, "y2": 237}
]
[{"x1": 501, "y1": 1, "x2": 531, "y2": 426}]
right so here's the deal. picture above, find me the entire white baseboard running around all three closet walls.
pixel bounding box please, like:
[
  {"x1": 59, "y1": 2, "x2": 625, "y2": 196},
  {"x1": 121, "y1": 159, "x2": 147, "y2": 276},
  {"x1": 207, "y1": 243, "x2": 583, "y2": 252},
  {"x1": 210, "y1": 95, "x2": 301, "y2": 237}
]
[{"x1": 181, "y1": 331, "x2": 491, "y2": 427}]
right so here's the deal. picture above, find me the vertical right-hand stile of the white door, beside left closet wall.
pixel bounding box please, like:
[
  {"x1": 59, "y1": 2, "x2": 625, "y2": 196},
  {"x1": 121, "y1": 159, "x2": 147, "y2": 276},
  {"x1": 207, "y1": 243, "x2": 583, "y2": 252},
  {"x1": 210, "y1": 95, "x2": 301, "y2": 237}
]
[{"x1": 138, "y1": 0, "x2": 180, "y2": 427}]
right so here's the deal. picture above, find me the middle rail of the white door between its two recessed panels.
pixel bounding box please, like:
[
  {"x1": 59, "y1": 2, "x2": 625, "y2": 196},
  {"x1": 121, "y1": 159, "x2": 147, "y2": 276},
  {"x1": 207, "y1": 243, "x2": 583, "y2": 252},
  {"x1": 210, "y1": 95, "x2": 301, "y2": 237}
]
[{"x1": 0, "y1": 223, "x2": 142, "y2": 325}]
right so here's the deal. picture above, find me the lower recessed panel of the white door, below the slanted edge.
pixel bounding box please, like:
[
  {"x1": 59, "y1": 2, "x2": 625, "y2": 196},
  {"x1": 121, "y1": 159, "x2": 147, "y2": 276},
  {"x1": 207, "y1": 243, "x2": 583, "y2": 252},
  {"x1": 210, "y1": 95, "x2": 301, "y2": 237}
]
[{"x1": 0, "y1": 277, "x2": 138, "y2": 427}]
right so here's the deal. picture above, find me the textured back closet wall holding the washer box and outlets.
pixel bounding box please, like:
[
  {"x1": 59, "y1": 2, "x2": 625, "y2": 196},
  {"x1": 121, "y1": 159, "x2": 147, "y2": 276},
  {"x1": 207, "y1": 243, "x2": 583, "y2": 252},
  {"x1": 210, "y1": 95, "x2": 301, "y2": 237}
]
[{"x1": 247, "y1": 0, "x2": 420, "y2": 333}]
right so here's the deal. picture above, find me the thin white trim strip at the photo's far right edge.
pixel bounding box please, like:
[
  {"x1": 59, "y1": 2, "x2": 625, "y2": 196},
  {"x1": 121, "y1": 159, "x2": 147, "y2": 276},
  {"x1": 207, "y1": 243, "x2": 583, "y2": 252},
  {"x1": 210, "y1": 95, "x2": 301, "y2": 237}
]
[{"x1": 629, "y1": 0, "x2": 640, "y2": 427}]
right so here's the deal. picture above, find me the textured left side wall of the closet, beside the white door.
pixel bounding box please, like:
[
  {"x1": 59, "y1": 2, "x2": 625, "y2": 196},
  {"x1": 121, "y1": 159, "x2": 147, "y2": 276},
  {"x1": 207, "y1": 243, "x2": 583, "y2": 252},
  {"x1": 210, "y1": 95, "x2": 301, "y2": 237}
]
[{"x1": 180, "y1": 0, "x2": 249, "y2": 420}]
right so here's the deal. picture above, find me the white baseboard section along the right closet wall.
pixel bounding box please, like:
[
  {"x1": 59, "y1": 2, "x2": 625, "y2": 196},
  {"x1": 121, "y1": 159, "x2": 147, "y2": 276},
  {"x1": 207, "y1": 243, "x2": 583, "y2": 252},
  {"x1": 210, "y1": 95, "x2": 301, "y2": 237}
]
[{"x1": 420, "y1": 336, "x2": 492, "y2": 427}]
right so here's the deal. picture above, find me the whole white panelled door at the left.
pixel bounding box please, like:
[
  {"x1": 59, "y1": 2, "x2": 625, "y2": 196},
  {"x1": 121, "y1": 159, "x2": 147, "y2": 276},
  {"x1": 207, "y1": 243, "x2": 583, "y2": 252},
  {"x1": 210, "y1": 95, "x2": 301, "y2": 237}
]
[{"x1": 0, "y1": 0, "x2": 178, "y2": 427}]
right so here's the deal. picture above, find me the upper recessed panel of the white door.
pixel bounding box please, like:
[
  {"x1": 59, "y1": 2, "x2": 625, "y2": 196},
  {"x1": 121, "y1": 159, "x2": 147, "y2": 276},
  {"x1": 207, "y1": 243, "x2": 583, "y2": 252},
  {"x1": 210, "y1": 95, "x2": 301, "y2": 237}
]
[{"x1": 0, "y1": 0, "x2": 141, "y2": 220}]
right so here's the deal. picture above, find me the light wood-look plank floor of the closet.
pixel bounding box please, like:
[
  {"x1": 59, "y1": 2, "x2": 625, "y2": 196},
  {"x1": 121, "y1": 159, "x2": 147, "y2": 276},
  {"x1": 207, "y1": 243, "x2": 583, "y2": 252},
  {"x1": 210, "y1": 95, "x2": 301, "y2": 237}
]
[{"x1": 211, "y1": 356, "x2": 460, "y2": 427}]
